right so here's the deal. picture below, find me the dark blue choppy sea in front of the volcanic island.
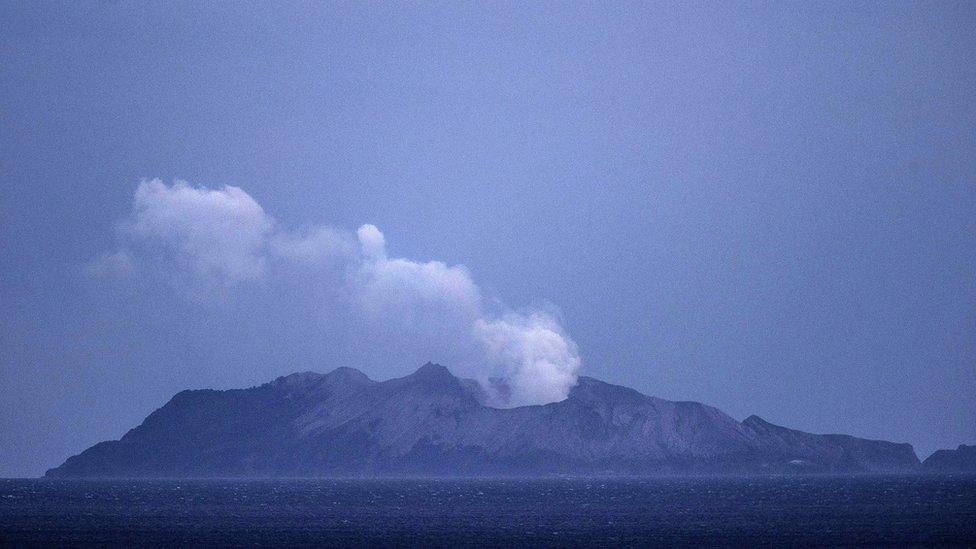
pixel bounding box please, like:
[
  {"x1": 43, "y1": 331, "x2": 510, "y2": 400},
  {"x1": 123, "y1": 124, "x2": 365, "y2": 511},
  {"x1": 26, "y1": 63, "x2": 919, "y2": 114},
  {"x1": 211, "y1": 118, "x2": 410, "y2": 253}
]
[{"x1": 0, "y1": 476, "x2": 976, "y2": 547}]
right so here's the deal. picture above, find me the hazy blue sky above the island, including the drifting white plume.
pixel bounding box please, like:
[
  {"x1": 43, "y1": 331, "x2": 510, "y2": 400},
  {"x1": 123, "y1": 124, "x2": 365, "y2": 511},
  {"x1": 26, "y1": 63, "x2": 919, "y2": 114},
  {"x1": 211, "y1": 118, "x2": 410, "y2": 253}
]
[{"x1": 0, "y1": 2, "x2": 976, "y2": 476}]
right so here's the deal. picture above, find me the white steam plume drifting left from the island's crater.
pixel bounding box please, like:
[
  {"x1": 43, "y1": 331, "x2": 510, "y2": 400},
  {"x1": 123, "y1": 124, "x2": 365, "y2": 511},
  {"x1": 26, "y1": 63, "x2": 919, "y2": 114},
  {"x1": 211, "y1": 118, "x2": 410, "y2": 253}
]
[{"x1": 90, "y1": 179, "x2": 580, "y2": 406}]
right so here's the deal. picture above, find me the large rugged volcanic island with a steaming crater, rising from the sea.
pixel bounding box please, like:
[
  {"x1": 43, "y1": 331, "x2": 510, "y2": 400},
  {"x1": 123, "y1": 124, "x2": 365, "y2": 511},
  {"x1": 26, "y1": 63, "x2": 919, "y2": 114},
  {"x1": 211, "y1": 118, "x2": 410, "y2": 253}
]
[{"x1": 47, "y1": 364, "x2": 919, "y2": 477}]
